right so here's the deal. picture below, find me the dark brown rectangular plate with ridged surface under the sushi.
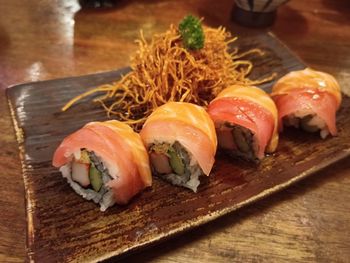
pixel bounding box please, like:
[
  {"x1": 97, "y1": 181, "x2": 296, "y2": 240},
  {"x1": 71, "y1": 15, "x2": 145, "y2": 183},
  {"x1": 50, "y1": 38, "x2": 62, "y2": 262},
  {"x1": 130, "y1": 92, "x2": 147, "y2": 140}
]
[{"x1": 7, "y1": 34, "x2": 350, "y2": 262}]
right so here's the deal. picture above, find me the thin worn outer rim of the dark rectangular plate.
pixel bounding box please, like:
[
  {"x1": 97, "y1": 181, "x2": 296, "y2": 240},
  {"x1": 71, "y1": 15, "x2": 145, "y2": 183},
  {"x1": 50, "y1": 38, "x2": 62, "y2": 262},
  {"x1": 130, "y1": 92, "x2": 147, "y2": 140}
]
[{"x1": 5, "y1": 32, "x2": 344, "y2": 262}]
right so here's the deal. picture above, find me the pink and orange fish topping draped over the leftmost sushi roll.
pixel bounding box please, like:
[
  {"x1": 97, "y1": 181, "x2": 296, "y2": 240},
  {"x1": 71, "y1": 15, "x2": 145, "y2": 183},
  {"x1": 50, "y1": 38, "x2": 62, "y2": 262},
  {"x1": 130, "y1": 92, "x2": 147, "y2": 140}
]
[{"x1": 53, "y1": 121, "x2": 152, "y2": 204}]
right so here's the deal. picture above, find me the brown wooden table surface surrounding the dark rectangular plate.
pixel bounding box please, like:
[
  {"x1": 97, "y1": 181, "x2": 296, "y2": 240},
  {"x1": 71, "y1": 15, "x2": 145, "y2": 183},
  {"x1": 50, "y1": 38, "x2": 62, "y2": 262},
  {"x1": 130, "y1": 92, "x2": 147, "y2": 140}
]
[{"x1": 0, "y1": 0, "x2": 350, "y2": 262}]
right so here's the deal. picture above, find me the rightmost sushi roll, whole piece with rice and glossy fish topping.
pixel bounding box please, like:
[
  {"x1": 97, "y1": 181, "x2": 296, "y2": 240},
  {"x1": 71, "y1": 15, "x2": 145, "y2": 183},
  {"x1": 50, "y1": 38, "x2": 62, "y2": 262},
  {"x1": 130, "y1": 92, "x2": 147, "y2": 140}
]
[{"x1": 271, "y1": 68, "x2": 341, "y2": 138}]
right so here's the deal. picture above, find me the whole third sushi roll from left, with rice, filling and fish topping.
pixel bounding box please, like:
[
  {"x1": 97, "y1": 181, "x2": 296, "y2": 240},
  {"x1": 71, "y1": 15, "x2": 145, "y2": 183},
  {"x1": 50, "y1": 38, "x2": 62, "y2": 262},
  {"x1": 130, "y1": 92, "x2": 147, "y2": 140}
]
[{"x1": 208, "y1": 85, "x2": 278, "y2": 162}]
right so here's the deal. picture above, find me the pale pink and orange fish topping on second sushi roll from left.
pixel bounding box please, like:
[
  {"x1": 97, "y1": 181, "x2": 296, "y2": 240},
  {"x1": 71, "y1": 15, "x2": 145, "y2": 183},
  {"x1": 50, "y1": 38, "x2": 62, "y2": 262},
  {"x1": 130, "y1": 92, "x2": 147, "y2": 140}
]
[{"x1": 140, "y1": 102, "x2": 217, "y2": 175}]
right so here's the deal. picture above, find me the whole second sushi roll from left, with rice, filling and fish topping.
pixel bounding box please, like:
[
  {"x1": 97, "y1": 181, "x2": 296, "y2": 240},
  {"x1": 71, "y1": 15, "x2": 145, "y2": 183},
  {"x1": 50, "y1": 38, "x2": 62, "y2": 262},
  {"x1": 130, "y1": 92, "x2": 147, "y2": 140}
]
[{"x1": 140, "y1": 102, "x2": 217, "y2": 192}]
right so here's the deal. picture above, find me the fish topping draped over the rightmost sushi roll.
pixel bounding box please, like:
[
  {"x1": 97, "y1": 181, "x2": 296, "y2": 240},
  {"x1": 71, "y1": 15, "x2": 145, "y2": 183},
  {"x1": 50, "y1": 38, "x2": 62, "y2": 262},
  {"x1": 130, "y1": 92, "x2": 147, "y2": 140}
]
[{"x1": 271, "y1": 68, "x2": 342, "y2": 136}]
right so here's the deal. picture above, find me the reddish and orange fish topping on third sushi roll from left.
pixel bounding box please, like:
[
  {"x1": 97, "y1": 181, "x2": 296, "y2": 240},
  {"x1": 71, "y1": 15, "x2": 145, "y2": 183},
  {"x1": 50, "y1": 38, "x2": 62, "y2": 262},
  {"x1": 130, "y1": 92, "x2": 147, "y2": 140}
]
[{"x1": 208, "y1": 85, "x2": 278, "y2": 159}]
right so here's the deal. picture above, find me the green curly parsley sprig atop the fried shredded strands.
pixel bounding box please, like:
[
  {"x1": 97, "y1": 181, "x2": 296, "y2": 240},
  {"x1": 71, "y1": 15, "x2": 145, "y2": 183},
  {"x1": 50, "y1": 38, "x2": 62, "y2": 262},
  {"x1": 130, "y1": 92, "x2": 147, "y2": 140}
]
[{"x1": 179, "y1": 15, "x2": 204, "y2": 50}]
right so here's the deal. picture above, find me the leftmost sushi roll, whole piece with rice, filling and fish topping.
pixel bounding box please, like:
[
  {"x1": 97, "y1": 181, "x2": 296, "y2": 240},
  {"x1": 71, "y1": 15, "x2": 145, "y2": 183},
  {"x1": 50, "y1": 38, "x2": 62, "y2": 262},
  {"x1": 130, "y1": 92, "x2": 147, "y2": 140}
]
[{"x1": 52, "y1": 120, "x2": 152, "y2": 211}]
